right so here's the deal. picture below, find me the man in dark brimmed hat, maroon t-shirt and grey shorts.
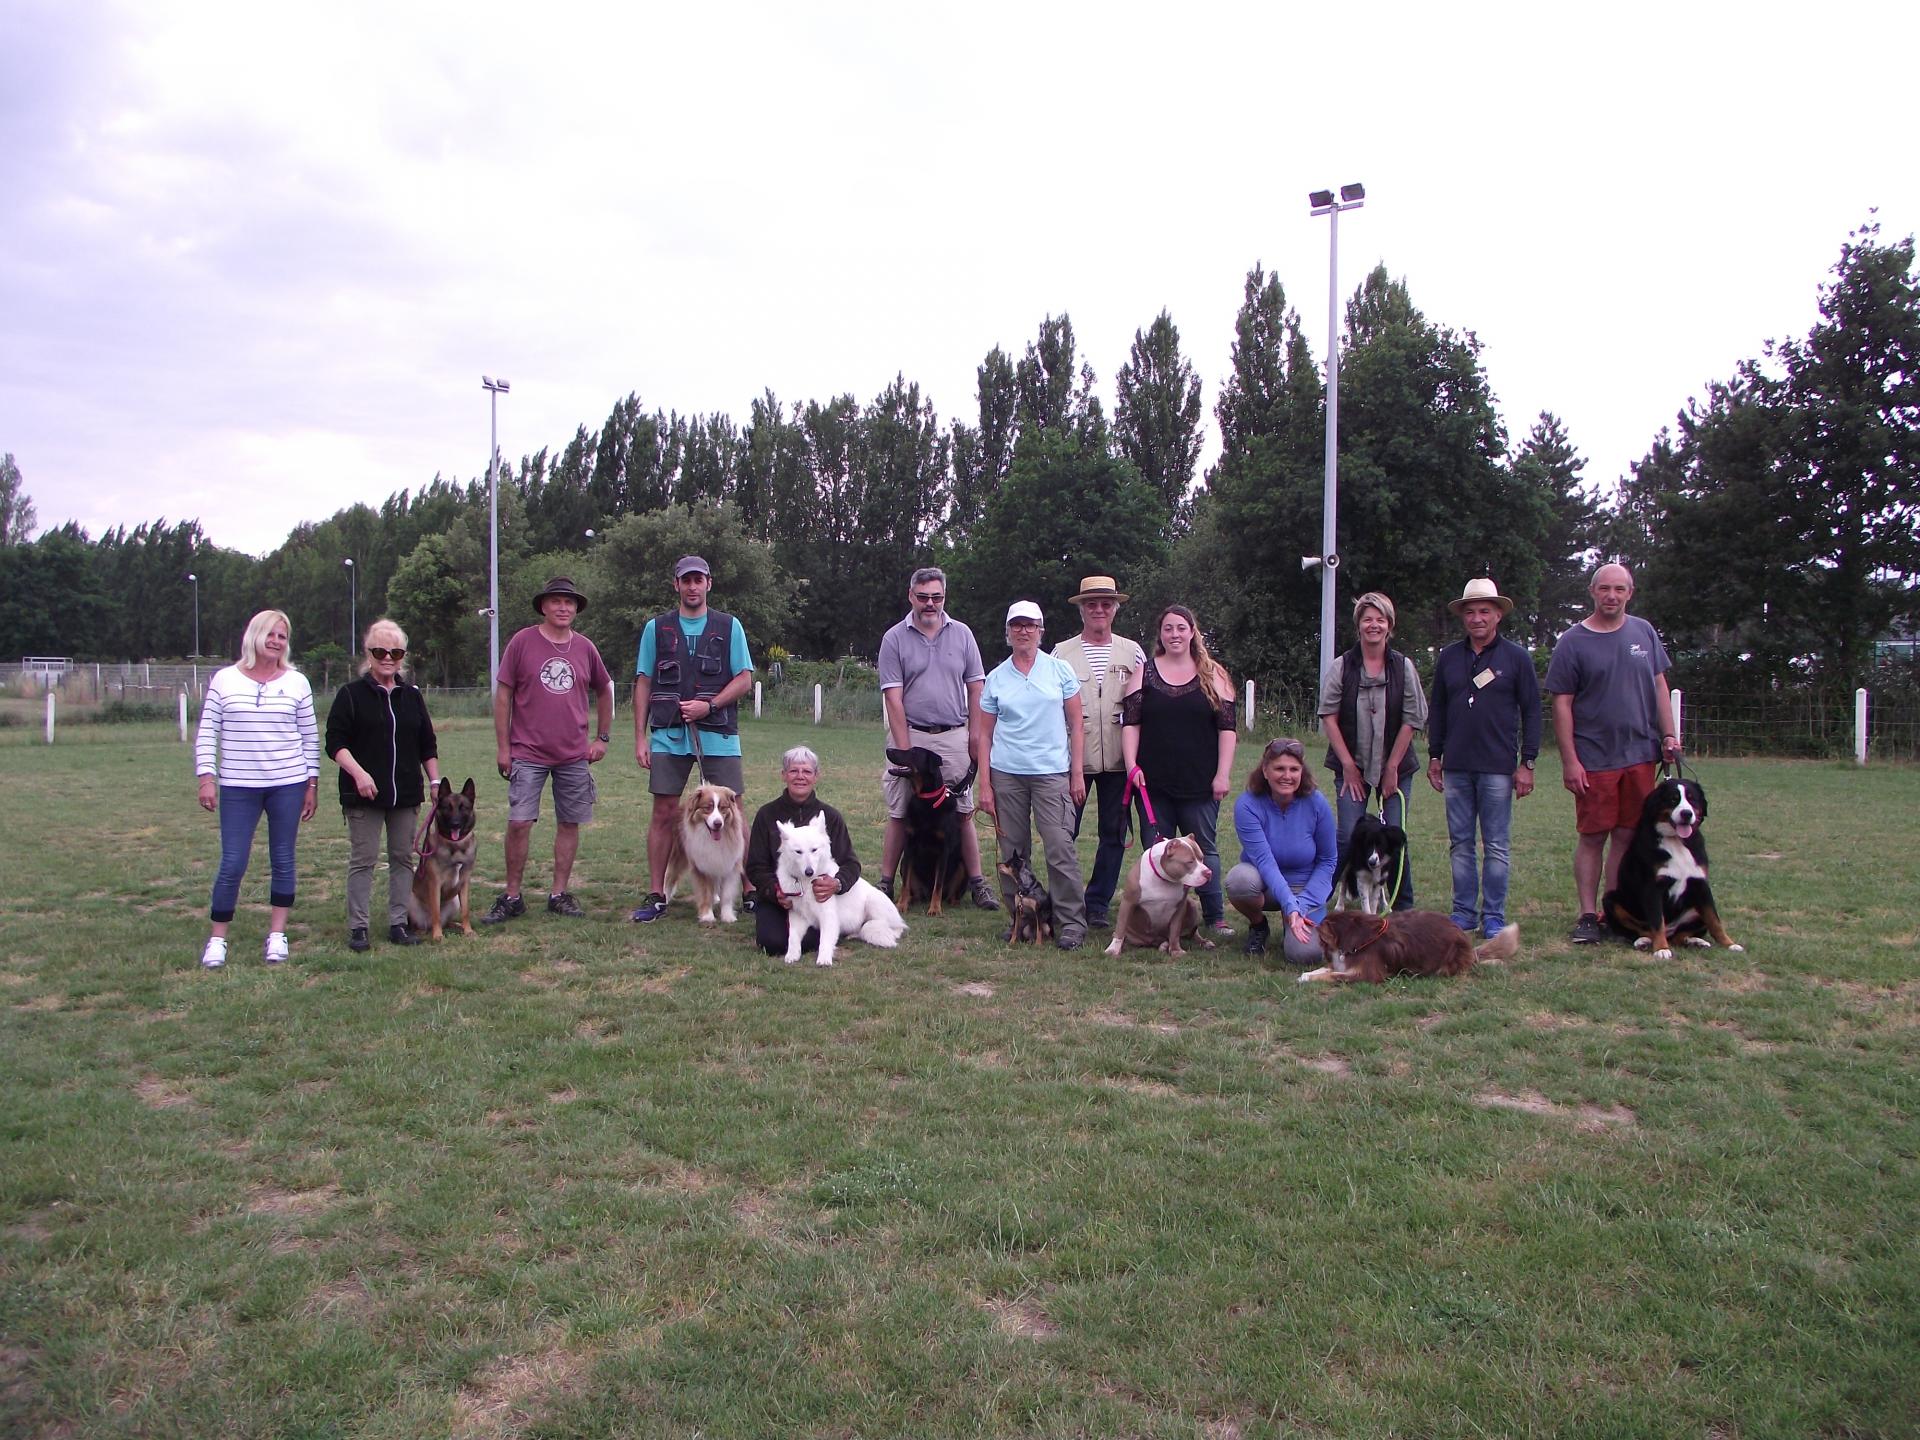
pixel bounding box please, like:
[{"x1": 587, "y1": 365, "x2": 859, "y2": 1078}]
[{"x1": 480, "y1": 576, "x2": 612, "y2": 925}]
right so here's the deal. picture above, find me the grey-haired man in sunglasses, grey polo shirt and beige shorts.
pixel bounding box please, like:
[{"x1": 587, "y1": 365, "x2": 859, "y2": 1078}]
[{"x1": 877, "y1": 564, "x2": 1000, "y2": 910}]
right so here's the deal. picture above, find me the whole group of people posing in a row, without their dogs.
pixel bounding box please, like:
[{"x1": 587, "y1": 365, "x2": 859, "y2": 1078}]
[{"x1": 196, "y1": 555, "x2": 1680, "y2": 968}]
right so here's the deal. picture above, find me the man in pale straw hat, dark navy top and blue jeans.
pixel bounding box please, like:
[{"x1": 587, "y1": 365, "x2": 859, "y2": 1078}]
[{"x1": 1427, "y1": 578, "x2": 1540, "y2": 937}]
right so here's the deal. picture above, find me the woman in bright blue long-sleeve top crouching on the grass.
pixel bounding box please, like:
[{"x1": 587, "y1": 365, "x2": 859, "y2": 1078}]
[{"x1": 1227, "y1": 739, "x2": 1338, "y2": 966}]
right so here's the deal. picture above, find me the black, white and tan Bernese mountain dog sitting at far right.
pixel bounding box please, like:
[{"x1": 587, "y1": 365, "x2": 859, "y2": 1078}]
[{"x1": 1601, "y1": 776, "x2": 1745, "y2": 960}]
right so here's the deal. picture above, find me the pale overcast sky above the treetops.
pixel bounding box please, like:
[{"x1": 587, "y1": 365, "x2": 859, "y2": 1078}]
[{"x1": 0, "y1": 0, "x2": 1920, "y2": 553}]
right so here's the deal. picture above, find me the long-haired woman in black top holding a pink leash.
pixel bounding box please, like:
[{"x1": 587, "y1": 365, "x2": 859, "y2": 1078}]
[{"x1": 1119, "y1": 605, "x2": 1235, "y2": 935}]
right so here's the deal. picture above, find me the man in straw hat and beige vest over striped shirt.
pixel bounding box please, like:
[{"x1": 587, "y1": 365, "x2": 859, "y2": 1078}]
[{"x1": 1054, "y1": 574, "x2": 1146, "y2": 929}]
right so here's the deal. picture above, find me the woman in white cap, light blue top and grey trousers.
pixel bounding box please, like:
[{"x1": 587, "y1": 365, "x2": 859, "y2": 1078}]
[{"x1": 973, "y1": 601, "x2": 1087, "y2": 950}]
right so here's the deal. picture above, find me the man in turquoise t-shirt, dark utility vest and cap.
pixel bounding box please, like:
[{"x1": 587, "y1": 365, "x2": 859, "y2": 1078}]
[{"x1": 632, "y1": 555, "x2": 753, "y2": 924}]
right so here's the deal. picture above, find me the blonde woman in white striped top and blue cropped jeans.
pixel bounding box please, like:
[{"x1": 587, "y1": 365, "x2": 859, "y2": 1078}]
[{"x1": 194, "y1": 611, "x2": 321, "y2": 970}]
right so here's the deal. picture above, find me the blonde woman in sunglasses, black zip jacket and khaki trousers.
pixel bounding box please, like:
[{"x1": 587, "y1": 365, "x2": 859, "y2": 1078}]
[{"x1": 326, "y1": 618, "x2": 440, "y2": 950}]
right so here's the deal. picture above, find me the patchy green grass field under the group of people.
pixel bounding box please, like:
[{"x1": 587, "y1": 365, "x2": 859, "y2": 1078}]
[{"x1": 0, "y1": 720, "x2": 1920, "y2": 1440}]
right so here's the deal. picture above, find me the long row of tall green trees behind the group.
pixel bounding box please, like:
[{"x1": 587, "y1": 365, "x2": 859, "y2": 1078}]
[{"x1": 0, "y1": 227, "x2": 1920, "y2": 684}]
